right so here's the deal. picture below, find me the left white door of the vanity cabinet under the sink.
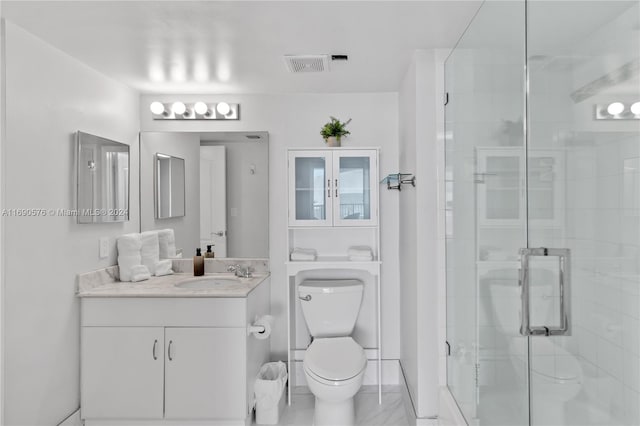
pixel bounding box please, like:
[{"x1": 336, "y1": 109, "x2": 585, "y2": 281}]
[{"x1": 81, "y1": 327, "x2": 164, "y2": 419}]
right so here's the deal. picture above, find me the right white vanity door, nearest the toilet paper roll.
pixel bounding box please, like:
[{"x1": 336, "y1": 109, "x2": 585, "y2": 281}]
[{"x1": 165, "y1": 327, "x2": 248, "y2": 420}]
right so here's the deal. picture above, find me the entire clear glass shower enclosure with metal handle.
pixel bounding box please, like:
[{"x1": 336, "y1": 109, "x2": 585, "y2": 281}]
[{"x1": 445, "y1": 0, "x2": 640, "y2": 426}]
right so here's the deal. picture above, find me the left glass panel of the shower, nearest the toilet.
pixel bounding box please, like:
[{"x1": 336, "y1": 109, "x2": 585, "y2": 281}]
[{"x1": 445, "y1": 1, "x2": 528, "y2": 426}]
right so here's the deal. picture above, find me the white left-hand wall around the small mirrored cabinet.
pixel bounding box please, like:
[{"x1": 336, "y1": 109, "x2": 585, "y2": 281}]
[{"x1": 2, "y1": 22, "x2": 139, "y2": 426}]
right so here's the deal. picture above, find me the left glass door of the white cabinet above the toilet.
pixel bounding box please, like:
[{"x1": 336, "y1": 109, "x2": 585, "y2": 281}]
[{"x1": 289, "y1": 151, "x2": 333, "y2": 226}]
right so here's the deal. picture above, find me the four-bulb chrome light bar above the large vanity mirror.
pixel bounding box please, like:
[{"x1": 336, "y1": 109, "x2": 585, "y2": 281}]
[{"x1": 149, "y1": 101, "x2": 240, "y2": 120}]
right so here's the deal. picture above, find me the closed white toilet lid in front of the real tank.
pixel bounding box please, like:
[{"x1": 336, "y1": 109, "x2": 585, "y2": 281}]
[{"x1": 304, "y1": 337, "x2": 367, "y2": 380}]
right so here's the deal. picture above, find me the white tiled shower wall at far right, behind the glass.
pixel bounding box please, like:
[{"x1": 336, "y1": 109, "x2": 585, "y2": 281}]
[{"x1": 566, "y1": 132, "x2": 640, "y2": 425}]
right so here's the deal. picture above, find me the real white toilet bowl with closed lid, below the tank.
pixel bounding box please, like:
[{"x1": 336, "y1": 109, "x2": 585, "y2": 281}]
[{"x1": 303, "y1": 337, "x2": 367, "y2": 426}]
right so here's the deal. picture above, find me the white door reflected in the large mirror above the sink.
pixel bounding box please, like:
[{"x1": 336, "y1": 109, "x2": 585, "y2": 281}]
[{"x1": 200, "y1": 146, "x2": 227, "y2": 257}]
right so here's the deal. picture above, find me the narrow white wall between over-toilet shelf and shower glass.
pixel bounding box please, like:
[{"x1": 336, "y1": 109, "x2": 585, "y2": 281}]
[{"x1": 399, "y1": 50, "x2": 444, "y2": 417}]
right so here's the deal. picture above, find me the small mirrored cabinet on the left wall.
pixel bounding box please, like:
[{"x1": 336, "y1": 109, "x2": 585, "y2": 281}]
[{"x1": 76, "y1": 131, "x2": 129, "y2": 223}]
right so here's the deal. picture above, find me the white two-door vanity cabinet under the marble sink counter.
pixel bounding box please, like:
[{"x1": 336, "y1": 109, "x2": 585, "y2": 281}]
[{"x1": 81, "y1": 278, "x2": 270, "y2": 426}]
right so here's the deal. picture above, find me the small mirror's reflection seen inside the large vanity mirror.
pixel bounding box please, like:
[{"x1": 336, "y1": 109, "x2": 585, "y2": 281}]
[{"x1": 154, "y1": 152, "x2": 185, "y2": 219}]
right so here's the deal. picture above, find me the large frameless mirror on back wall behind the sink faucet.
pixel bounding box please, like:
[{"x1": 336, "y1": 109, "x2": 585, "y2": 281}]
[{"x1": 140, "y1": 132, "x2": 269, "y2": 258}]
